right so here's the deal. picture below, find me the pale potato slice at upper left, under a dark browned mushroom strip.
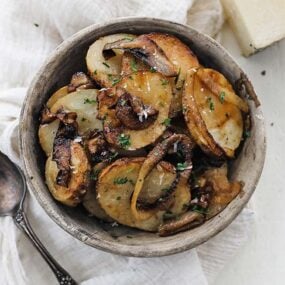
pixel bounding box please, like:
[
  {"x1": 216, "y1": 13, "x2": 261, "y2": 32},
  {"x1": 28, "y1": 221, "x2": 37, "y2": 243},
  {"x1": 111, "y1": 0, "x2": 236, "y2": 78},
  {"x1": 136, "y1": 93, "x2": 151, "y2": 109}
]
[{"x1": 86, "y1": 34, "x2": 135, "y2": 87}]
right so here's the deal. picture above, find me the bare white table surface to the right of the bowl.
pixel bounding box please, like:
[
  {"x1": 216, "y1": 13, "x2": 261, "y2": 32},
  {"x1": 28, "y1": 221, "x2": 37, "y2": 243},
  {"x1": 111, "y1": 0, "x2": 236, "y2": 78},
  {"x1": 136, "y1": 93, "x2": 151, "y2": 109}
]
[{"x1": 215, "y1": 23, "x2": 285, "y2": 285}]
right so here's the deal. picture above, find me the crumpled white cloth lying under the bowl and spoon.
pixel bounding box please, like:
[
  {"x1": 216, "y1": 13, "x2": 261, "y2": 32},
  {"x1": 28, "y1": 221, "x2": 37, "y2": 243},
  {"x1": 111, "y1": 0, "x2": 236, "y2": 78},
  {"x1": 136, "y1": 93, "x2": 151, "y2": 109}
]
[{"x1": 0, "y1": 0, "x2": 253, "y2": 285}]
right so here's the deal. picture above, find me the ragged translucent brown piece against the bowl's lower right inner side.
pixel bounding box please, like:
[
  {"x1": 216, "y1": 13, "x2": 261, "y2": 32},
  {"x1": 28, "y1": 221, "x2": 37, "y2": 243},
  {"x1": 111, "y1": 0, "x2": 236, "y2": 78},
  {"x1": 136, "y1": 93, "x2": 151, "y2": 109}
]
[{"x1": 202, "y1": 164, "x2": 242, "y2": 219}]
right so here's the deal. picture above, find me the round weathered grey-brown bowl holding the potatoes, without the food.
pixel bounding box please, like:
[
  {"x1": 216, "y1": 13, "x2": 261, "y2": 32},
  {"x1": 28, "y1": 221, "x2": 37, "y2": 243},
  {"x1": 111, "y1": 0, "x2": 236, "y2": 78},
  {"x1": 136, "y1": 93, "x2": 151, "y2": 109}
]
[{"x1": 20, "y1": 18, "x2": 266, "y2": 257}]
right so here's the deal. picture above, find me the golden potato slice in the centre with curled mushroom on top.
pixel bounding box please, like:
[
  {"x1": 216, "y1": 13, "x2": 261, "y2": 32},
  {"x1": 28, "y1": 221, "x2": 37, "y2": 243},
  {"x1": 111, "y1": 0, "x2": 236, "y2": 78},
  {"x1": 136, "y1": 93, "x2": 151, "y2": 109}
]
[{"x1": 118, "y1": 71, "x2": 172, "y2": 150}]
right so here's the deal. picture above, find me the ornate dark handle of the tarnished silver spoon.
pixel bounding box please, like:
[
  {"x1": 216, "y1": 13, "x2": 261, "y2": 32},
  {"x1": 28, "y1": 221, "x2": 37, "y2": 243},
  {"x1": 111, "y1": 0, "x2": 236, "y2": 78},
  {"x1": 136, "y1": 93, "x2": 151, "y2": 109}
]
[{"x1": 14, "y1": 209, "x2": 77, "y2": 285}]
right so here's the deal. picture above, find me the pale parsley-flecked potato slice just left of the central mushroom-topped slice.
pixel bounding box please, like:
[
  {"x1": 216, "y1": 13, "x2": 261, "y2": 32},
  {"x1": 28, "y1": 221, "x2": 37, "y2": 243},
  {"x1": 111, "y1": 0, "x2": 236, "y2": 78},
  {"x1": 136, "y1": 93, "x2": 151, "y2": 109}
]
[{"x1": 51, "y1": 89, "x2": 102, "y2": 134}]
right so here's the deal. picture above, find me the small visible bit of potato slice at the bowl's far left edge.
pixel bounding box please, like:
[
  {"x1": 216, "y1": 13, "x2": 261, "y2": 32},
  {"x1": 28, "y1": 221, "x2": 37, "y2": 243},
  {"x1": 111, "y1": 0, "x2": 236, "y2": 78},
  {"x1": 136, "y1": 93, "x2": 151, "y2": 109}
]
[{"x1": 38, "y1": 120, "x2": 59, "y2": 156}]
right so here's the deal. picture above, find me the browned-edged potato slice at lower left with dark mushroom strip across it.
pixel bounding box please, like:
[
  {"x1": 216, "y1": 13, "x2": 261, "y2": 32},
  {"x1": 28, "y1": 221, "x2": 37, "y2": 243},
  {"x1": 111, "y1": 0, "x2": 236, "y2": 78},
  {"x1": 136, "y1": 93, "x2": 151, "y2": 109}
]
[{"x1": 45, "y1": 142, "x2": 90, "y2": 207}]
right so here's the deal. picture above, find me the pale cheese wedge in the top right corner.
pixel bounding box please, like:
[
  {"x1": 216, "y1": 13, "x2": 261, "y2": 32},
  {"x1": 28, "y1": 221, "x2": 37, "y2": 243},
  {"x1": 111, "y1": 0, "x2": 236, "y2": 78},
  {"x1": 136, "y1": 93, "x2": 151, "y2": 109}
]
[{"x1": 222, "y1": 0, "x2": 285, "y2": 56}]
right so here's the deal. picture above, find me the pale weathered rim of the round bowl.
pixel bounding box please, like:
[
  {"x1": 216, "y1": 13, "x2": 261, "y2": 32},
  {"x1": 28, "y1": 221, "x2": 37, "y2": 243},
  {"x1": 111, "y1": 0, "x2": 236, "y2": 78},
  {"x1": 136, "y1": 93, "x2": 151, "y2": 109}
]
[{"x1": 19, "y1": 17, "x2": 266, "y2": 257}]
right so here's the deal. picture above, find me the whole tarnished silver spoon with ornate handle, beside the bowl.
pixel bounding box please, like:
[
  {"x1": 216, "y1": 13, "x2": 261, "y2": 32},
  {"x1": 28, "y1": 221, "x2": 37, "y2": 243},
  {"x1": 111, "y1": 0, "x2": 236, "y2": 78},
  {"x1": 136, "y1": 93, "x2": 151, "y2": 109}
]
[{"x1": 0, "y1": 152, "x2": 77, "y2": 285}]
